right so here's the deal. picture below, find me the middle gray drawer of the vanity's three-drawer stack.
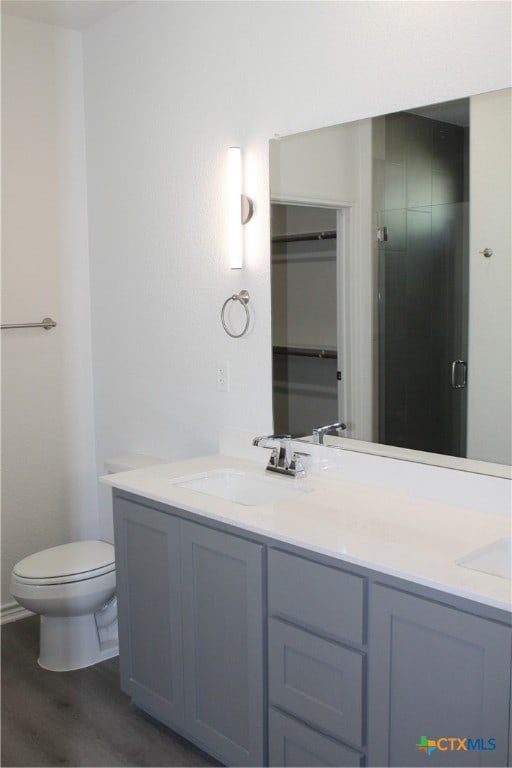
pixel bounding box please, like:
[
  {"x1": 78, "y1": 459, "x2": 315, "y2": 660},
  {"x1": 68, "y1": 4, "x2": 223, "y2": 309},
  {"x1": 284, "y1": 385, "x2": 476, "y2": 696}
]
[{"x1": 268, "y1": 619, "x2": 365, "y2": 746}]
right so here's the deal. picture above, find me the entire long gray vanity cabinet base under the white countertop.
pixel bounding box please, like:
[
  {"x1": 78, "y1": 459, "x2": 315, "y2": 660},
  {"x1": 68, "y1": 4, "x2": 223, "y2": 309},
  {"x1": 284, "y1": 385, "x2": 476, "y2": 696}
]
[{"x1": 114, "y1": 492, "x2": 512, "y2": 768}]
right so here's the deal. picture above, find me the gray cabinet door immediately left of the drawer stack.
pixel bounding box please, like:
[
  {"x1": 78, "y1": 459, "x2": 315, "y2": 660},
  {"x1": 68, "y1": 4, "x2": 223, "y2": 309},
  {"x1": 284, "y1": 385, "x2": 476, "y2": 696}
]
[{"x1": 182, "y1": 522, "x2": 264, "y2": 765}]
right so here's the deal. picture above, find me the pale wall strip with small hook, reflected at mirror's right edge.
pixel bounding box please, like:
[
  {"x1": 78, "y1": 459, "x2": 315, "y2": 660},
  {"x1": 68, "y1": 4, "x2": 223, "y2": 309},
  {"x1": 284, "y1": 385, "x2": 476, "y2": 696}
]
[{"x1": 468, "y1": 90, "x2": 512, "y2": 464}]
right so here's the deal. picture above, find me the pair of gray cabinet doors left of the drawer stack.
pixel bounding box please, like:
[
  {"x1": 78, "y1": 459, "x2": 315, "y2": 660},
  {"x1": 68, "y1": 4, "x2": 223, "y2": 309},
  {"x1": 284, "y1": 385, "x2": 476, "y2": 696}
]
[{"x1": 114, "y1": 495, "x2": 266, "y2": 766}]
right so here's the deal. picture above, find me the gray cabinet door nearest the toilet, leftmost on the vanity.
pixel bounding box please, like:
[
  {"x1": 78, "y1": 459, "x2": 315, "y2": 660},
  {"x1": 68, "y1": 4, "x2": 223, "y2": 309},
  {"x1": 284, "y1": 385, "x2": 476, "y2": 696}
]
[{"x1": 114, "y1": 498, "x2": 184, "y2": 727}]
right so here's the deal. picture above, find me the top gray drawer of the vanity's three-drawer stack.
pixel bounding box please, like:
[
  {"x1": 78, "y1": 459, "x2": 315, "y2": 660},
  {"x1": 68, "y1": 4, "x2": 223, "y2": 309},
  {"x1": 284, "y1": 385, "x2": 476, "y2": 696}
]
[{"x1": 269, "y1": 549, "x2": 365, "y2": 645}]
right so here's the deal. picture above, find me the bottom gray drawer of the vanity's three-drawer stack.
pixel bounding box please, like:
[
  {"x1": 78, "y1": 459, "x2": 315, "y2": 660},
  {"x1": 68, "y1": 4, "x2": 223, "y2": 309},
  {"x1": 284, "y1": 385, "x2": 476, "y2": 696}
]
[{"x1": 269, "y1": 708, "x2": 363, "y2": 768}]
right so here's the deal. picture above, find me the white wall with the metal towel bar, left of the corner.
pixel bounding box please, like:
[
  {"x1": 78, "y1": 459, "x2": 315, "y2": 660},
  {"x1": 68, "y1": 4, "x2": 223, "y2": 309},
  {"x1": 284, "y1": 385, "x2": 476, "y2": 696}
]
[{"x1": 2, "y1": 16, "x2": 98, "y2": 609}]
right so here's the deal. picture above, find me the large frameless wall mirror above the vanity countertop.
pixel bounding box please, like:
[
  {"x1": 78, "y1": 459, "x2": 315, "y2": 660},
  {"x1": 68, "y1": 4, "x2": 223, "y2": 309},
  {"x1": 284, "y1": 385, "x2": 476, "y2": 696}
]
[{"x1": 270, "y1": 89, "x2": 512, "y2": 476}]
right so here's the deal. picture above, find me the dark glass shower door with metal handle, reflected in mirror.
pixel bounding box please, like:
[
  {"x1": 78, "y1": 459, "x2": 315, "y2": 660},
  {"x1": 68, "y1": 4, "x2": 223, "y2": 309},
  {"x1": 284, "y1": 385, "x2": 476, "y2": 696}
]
[{"x1": 378, "y1": 203, "x2": 468, "y2": 456}]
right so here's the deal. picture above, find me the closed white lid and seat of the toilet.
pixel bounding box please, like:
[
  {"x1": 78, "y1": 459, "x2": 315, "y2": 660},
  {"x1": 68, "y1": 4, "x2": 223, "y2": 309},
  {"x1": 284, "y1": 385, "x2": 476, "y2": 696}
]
[{"x1": 13, "y1": 541, "x2": 115, "y2": 581}]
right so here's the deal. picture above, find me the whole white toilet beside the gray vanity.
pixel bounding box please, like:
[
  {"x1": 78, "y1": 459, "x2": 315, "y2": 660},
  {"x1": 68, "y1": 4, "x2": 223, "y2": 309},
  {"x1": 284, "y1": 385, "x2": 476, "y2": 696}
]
[{"x1": 11, "y1": 454, "x2": 164, "y2": 672}]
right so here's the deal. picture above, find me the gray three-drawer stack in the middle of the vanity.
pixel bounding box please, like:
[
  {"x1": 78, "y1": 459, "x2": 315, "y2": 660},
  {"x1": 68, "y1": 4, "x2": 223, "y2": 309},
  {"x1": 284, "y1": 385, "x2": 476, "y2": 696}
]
[{"x1": 268, "y1": 549, "x2": 366, "y2": 766}]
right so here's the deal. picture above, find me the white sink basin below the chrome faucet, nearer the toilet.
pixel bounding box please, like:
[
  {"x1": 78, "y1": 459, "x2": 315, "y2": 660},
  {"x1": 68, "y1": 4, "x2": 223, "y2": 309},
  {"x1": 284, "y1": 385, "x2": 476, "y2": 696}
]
[{"x1": 170, "y1": 469, "x2": 313, "y2": 507}]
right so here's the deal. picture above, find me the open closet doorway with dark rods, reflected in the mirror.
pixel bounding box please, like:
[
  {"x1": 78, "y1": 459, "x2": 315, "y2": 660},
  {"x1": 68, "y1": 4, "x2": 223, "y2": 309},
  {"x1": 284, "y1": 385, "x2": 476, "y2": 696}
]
[{"x1": 271, "y1": 202, "x2": 342, "y2": 437}]
